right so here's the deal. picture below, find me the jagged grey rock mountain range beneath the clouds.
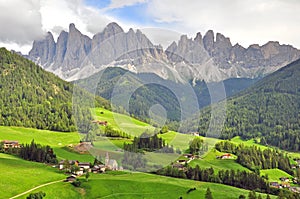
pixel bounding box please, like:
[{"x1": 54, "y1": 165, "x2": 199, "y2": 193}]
[{"x1": 28, "y1": 23, "x2": 300, "y2": 82}]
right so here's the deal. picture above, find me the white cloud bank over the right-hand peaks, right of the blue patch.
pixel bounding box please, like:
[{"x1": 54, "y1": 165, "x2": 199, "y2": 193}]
[{"x1": 147, "y1": 0, "x2": 300, "y2": 48}]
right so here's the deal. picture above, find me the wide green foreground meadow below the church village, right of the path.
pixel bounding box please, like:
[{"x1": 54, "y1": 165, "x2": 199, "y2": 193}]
[{"x1": 26, "y1": 173, "x2": 275, "y2": 199}]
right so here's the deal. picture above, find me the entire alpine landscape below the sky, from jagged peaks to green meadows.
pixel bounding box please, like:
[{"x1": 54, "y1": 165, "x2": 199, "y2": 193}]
[{"x1": 0, "y1": 15, "x2": 300, "y2": 199}]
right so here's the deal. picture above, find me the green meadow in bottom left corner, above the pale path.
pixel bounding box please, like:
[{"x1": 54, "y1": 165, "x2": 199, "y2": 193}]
[{"x1": 0, "y1": 153, "x2": 65, "y2": 198}]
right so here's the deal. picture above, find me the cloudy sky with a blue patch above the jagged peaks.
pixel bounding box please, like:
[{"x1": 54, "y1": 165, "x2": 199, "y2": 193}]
[{"x1": 0, "y1": 0, "x2": 300, "y2": 54}]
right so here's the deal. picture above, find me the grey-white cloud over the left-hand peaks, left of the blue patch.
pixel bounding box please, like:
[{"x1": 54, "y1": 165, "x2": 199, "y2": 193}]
[{"x1": 0, "y1": 0, "x2": 111, "y2": 54}]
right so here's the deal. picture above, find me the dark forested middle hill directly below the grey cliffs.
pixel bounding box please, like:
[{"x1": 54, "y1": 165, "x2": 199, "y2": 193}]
[{"x1": 75, "y1": 67, "x2": 257, "y2": 126}]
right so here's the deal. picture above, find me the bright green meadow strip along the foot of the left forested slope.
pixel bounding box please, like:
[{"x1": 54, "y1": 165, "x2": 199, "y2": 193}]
[{"x1": 0, "y1": 126, "x2": 93, "y2": 162}]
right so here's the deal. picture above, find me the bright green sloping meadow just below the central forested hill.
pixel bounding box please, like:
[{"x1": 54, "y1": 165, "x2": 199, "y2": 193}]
[{"x1": 93, "y1": 108, "x2": 155, "y2": 136}]
